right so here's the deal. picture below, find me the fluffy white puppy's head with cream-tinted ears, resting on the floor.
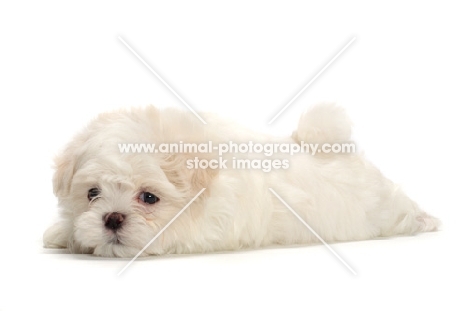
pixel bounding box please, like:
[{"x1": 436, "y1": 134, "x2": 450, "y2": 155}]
[{"x1": 44, "y1": 107, "x2": 216, "y2": 257}]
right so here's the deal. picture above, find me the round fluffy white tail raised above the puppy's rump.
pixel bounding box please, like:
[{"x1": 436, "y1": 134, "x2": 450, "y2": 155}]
[{"x1": 292, "y1": 103, "x2": 352, "y2": 144}]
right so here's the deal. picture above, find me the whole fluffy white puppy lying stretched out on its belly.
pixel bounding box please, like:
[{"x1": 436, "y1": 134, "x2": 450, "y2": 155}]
[{"x1": 44, "y1": 104, "x2": 439, "y2": 257}]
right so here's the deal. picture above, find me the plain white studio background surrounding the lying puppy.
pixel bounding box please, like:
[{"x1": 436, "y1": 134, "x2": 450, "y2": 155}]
[{"x1": 0, "y1": 1, "x2": 468, "y2": 310}]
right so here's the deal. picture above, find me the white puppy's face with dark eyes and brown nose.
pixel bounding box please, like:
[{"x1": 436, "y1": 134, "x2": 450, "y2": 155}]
[{"x1": 63, "y1": 155, "x2": 185, "y2": 257}]
